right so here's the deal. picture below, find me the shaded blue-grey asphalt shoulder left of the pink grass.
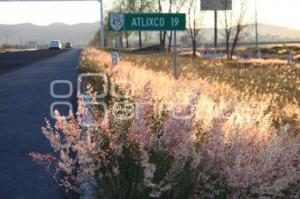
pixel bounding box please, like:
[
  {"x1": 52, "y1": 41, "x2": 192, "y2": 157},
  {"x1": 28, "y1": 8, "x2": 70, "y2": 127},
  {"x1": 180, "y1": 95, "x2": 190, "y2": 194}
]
[{"x1": 0, "y1": 49, "x2": 81, "y2": 199}]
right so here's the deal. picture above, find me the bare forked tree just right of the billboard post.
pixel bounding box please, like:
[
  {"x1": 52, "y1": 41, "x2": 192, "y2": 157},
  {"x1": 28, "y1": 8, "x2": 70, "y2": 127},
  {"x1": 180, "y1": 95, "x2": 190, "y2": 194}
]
[{"x1": 224, "y1": 0, "x2": 247, "y2": 60}]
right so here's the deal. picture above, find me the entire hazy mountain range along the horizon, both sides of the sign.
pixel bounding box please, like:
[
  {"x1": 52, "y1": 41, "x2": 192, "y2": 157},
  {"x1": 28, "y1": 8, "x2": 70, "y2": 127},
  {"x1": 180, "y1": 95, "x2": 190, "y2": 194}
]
[{"x1": 0, "y1": 22, "x2": 300, "y2": 46}]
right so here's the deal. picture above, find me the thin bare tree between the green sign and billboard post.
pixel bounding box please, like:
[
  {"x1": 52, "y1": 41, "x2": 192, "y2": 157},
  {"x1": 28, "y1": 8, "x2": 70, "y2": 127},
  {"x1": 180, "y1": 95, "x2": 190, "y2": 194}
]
[{"x1": 187, "y1": 0, "x2": 202, "y2": 58}]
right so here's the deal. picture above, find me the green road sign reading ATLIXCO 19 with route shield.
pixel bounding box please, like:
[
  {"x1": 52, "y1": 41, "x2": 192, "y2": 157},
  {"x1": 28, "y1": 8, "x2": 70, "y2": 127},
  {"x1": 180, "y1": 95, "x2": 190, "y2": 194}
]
[{"x1": 109, "y1": 13, "x2": 186, "y2": 31}]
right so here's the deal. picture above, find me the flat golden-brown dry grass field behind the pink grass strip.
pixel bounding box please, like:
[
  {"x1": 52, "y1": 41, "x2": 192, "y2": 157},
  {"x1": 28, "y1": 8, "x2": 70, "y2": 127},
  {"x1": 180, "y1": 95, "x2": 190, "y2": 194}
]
[{"x1": 123, "y1": 51, "x2": 300, "y2": 103}]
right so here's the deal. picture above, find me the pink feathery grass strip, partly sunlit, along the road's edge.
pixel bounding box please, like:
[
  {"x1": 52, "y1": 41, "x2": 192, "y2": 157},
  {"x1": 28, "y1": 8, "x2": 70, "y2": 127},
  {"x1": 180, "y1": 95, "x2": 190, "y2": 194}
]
[{"x1": 32, "y1": 49, "x2": 300, "y2": 199}]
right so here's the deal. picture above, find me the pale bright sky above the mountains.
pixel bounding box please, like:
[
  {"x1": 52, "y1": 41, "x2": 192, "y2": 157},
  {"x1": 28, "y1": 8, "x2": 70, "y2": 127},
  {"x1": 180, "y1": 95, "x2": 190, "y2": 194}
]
[{"x1": 0, "y1": 0, "x2": 300, "y2": 30}]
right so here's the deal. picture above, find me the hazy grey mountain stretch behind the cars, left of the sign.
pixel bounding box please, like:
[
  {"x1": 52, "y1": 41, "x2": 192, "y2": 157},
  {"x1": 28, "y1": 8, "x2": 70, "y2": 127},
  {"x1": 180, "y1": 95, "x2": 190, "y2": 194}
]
[{"x1": 0, "y1": 22, "x2": 99, "y2": 45}]
